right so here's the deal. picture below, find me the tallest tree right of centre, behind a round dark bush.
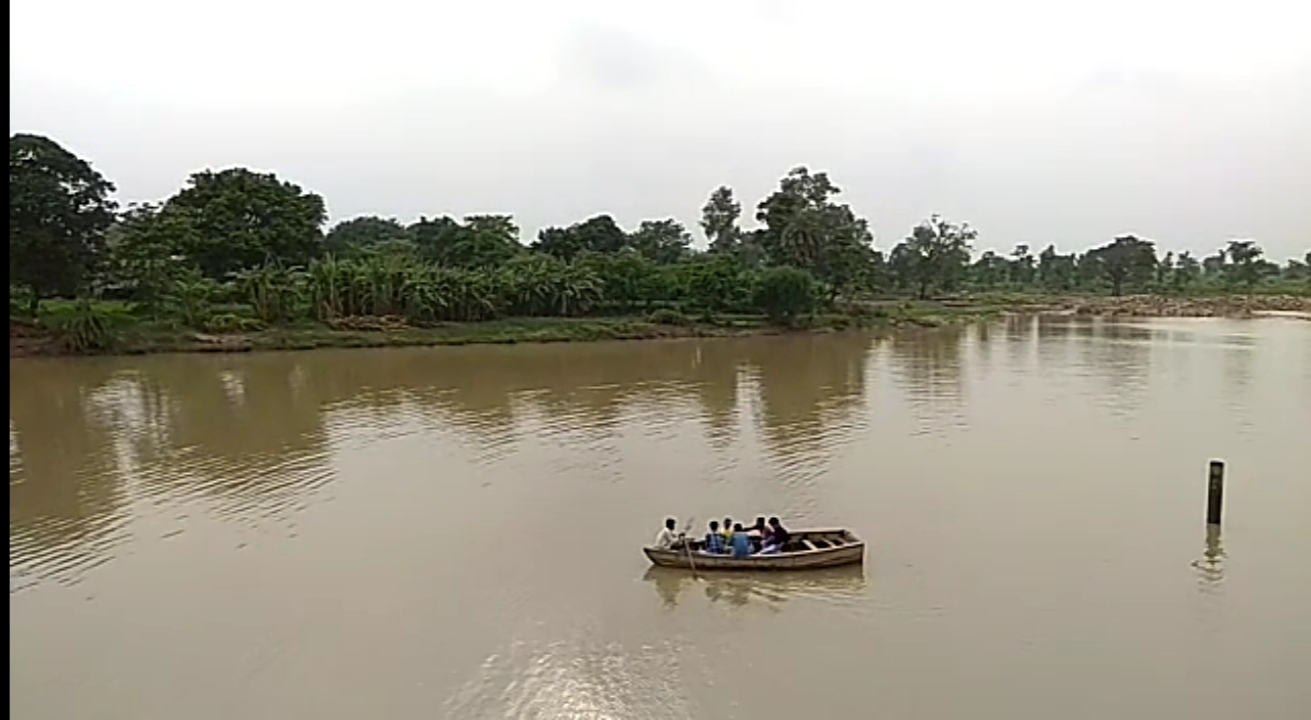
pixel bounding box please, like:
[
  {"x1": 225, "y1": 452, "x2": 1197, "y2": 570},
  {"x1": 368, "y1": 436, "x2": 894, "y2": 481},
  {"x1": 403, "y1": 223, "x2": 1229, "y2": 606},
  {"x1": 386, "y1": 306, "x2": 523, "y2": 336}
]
[{"x1": 755, "y1": 167, "x2": 873, "y2": 292}]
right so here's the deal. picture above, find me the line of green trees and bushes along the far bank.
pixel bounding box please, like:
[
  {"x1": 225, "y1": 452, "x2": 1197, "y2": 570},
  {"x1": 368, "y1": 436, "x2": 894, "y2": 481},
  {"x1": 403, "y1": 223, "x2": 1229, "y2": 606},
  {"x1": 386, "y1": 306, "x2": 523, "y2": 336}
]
[{"x1": 9, "y1": 134, "x2": 1311, "y2": 323}]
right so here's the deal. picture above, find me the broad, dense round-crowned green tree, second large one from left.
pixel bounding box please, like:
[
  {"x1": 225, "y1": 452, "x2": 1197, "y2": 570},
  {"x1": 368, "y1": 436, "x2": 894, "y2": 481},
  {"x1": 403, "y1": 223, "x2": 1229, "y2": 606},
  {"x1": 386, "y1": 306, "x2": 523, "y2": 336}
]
[{"x1": 164, "y1": 168, "x2": 328, "y2": 279}]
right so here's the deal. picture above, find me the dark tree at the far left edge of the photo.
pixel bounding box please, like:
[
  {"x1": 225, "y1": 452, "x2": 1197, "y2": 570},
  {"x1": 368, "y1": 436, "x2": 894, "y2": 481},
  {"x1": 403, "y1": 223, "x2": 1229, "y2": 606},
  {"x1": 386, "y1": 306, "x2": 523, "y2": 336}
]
[{"x1": 9, "y1": 134, "x2": 118, "y2": 315}]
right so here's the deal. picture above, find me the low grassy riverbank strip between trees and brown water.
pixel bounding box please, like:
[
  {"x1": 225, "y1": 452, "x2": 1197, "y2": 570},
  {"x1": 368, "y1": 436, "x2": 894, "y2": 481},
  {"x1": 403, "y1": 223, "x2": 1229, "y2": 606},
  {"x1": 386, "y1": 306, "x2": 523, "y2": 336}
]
[{"x1": 9, "y1": 295, "x2": 1311, "y2": 358}]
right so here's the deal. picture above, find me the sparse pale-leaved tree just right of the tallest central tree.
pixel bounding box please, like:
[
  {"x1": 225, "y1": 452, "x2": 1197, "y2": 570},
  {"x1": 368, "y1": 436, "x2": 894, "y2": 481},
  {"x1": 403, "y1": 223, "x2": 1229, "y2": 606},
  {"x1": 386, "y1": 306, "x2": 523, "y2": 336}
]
[{"x1": 889, "y1": 215, "x2": 978, "y2": 300}]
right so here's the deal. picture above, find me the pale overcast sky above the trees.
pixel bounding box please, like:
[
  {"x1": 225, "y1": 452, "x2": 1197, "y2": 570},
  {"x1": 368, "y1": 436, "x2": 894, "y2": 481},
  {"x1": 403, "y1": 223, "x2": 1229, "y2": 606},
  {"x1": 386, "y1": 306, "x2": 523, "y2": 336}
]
[{"x1": 9, "y1": 0, "x2": 1311, "y2": 260}]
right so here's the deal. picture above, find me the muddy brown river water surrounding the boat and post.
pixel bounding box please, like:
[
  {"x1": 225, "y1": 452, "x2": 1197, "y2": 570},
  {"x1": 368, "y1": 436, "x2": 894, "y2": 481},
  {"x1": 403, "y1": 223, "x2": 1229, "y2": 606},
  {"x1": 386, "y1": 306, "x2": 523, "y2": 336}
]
[{"x1": 9, "y1": 317, "x2": 1311, "y2": 720}]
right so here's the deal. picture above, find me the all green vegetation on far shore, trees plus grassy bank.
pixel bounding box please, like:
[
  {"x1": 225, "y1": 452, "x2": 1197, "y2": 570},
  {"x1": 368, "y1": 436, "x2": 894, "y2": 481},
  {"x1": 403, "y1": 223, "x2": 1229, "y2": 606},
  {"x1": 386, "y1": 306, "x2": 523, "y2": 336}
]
[{"x1": 9, "y1": 135, "x2": 1311, "y2": 353}]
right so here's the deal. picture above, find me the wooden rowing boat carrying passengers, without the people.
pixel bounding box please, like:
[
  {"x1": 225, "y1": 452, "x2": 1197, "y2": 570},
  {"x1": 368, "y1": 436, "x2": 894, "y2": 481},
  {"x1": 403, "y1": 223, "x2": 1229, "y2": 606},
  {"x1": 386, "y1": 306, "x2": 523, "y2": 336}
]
[{"x1": 642, "y1": 529, "x2": 865, "y2": 572}]
